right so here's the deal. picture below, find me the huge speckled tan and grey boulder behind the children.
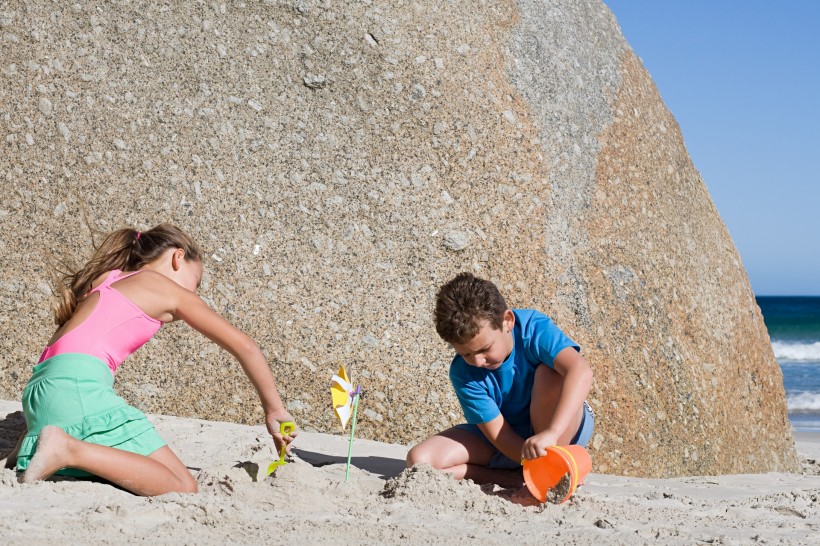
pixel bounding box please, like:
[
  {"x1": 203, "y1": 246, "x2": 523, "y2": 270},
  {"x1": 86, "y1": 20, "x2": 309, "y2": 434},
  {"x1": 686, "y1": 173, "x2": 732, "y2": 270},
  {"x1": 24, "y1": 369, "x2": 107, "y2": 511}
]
[{"x1": 0, "y1": 0, "x2": 797, "y2": 476}]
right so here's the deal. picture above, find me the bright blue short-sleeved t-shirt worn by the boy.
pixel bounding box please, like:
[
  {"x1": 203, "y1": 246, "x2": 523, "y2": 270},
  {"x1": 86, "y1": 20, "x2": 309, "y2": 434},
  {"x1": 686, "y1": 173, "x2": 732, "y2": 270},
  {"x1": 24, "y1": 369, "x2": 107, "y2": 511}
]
[{"x1": 450, "y1": 309, "x2": 581, "y2": 427}]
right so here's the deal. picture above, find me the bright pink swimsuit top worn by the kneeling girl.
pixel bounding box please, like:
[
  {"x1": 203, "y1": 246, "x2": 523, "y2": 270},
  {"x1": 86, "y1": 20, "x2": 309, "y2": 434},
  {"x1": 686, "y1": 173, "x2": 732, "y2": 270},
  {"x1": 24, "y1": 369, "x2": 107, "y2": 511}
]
[{"x1": 38, "y1": 269, "x2": 162, "y2": 374}]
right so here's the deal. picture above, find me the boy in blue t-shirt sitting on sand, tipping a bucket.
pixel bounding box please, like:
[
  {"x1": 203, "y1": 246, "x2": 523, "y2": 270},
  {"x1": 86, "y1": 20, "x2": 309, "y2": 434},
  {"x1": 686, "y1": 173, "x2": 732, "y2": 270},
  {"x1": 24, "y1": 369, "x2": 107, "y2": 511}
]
[{"x1": 407, "y1": 273, "x2": 593, "y2": 487}]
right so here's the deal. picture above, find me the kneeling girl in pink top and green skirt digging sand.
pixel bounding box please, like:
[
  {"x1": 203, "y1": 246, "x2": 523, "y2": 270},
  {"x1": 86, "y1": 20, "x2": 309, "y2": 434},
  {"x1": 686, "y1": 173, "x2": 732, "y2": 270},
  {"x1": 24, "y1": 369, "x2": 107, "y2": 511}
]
[{"x1": 11, "y1": 224, "x2": 296, "y2": 495}]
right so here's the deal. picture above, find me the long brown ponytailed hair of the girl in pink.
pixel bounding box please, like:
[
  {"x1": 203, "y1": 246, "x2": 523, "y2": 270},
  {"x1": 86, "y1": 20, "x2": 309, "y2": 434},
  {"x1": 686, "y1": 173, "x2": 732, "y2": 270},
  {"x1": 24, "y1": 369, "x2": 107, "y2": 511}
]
[{"x1": 53, "y1": 224, "x2": 202, "y2": 326}]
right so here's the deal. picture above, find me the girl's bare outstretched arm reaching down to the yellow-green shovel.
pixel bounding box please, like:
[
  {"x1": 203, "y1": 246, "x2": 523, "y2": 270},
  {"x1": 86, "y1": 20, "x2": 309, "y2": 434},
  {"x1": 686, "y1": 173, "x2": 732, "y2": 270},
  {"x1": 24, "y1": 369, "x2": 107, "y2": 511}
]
[{"x1": 168, "y1": 280, "x2": 296, "y2": 450}]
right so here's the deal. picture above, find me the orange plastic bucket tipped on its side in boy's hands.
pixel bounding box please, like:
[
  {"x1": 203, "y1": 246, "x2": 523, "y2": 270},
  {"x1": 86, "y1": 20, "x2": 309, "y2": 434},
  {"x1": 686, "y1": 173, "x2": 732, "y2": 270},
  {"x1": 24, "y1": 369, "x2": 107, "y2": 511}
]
[{"x1": 524, "y1": 445, "x2": 592, "y2": 504}]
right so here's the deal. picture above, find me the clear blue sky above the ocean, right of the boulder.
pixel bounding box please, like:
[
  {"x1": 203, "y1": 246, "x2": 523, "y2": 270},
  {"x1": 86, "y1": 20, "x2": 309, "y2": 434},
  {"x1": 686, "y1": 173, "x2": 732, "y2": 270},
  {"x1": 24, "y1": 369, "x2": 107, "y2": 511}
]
[{"x1": 604, "y1": 0, "x2": 820, "y2": 295}]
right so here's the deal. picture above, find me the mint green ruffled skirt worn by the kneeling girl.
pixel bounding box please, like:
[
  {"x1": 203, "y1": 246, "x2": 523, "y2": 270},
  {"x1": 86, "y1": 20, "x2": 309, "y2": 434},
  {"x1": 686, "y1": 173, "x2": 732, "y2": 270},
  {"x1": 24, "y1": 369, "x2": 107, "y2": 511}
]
[{"x1": 17, "y1": 353, "x2": 166, "y2": 477}]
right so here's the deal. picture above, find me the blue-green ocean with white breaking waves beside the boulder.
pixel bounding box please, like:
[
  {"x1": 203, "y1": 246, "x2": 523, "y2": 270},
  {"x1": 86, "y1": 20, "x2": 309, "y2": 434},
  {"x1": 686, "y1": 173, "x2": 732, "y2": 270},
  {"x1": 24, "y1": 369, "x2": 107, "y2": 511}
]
[{"x1": 756, "y1": 296, "x2": 820, "y2": 432}]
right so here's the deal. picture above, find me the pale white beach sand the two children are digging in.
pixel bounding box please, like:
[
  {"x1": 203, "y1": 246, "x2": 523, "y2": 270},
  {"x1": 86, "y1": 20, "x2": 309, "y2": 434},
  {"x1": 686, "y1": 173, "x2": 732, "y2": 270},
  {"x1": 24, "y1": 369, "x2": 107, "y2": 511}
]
[{"x1": 0, "y1": 401, "x2": 820, "y2": 545}]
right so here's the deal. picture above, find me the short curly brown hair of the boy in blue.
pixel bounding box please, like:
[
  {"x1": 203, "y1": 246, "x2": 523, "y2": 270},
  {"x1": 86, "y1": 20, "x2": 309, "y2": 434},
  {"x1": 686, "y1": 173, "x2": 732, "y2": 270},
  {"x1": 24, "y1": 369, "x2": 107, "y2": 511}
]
[{"x1": 435, "y1": 273, "x2": 507, "y2": 343}]
